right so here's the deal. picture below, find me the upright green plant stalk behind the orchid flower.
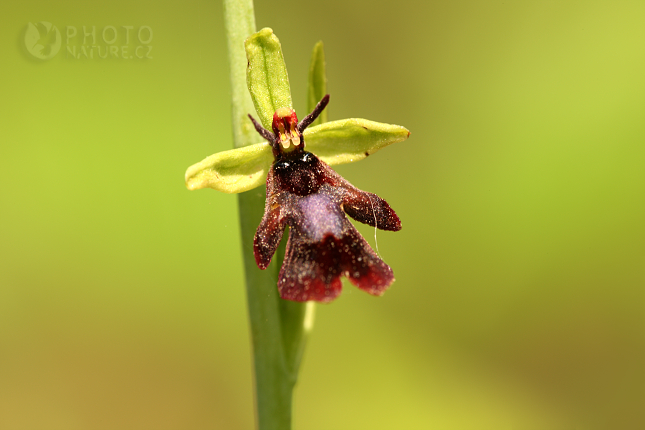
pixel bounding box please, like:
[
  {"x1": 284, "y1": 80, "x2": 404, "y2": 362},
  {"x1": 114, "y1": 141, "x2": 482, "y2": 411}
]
[{"x1": 224, "y1": 0, "x2": 313, "y2": 430}]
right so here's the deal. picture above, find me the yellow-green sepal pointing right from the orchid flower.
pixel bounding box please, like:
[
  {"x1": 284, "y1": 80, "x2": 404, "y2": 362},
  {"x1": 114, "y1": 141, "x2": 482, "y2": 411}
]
[{"x1": 304, "y1": 118, "x2": 410, "y2": 166}]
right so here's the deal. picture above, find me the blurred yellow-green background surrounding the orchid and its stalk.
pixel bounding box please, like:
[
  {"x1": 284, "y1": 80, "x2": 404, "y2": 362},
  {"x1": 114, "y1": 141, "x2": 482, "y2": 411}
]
[{"x1": 0, "y1": 0, "x2": 645, "y2": 430}]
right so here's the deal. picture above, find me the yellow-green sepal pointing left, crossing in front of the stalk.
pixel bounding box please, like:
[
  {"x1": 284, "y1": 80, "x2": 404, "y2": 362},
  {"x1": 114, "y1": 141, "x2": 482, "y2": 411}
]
[{"x1": 186, "y1": 142, "x2": 273, "y2": 194}]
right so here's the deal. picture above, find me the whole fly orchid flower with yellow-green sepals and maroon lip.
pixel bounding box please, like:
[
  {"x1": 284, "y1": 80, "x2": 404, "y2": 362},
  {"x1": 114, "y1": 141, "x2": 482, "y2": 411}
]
[{"x1": 186, "y1": 29, "x2": 410, "y2": 302}]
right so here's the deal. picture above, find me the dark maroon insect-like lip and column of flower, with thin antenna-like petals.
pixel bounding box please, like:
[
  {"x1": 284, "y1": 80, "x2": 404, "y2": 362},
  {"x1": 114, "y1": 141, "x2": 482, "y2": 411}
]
[{"x1": 249, "y1": 95, "x2": 401, "y2": 302}]
